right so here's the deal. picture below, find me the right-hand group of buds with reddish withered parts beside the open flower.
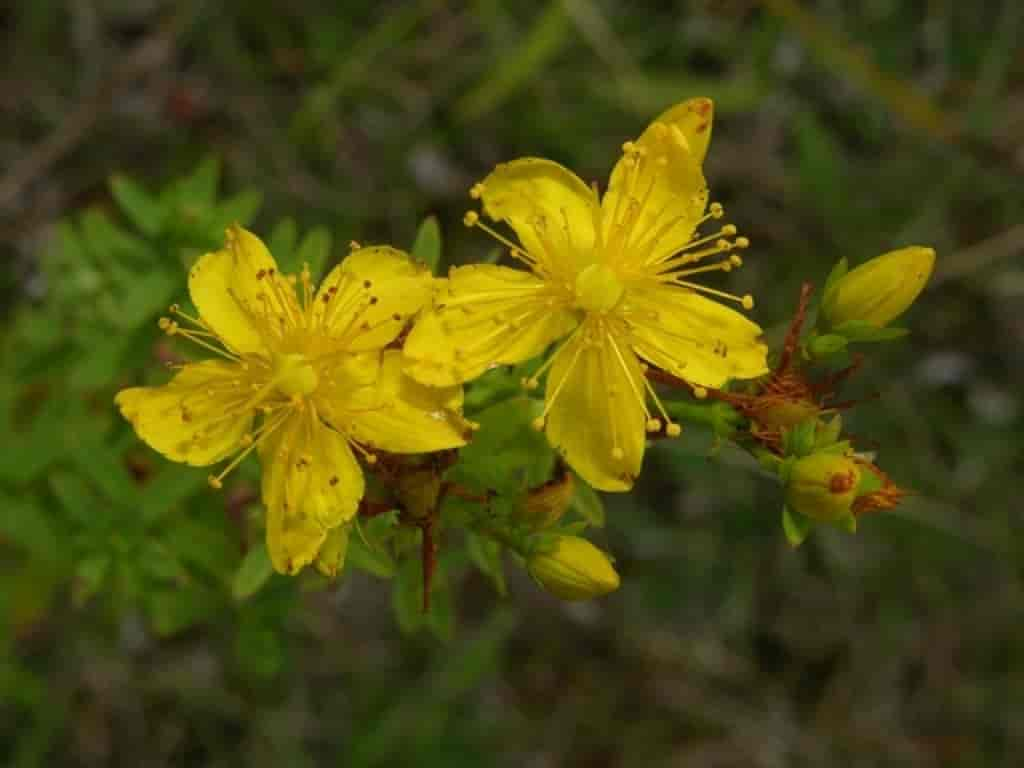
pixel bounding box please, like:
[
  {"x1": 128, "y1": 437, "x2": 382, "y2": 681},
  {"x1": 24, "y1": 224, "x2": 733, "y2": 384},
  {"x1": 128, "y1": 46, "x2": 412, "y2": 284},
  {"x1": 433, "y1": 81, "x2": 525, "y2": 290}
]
[{"x1": 648, "y1": 246, "x2": 935, "y2": 546}]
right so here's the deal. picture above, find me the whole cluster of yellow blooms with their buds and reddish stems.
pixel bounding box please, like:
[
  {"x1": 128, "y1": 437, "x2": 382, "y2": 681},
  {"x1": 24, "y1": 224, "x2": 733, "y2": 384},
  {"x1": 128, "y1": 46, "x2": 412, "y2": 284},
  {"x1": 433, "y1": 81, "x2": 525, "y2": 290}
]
[{"x1": 117, "y1": 98, "x2": 931, "y2": 599}]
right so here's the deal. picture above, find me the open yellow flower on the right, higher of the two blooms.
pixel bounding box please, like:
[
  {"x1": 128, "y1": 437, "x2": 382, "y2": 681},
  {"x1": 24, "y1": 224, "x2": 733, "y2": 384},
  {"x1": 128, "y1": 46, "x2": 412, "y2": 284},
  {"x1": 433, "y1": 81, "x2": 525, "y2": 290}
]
[{"x1": 404, "y1": 98, "x2": 767, "y2": 490}]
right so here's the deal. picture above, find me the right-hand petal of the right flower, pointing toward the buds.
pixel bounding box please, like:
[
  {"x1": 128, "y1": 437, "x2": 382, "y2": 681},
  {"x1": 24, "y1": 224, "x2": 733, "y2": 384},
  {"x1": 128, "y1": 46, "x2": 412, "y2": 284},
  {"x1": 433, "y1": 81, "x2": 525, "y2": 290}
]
[{"x1": 626, "y1": 285, "x2": 768, "y2": 387}]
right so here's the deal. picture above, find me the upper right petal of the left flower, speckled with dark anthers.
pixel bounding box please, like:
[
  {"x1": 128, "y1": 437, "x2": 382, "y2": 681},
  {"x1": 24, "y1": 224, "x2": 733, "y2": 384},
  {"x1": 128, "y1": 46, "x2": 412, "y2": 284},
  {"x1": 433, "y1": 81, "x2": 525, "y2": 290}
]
[{"x1": 313, "y1": 246, "x2": 433, "y2": 351}]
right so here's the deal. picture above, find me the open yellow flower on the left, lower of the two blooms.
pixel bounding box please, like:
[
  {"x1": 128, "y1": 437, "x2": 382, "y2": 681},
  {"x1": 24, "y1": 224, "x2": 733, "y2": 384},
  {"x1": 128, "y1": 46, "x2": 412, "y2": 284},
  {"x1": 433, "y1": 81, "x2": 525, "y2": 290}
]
[{"x1": 116, "y1": 226, "x2": 467, "y2": 573}]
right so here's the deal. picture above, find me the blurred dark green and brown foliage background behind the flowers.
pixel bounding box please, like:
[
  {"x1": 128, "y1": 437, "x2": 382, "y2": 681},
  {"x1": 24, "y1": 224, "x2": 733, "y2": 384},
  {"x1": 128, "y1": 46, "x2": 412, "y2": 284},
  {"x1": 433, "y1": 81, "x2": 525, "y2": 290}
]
[{"x1": 0, "y1": 0, "x2": 1024, "y2": 768}]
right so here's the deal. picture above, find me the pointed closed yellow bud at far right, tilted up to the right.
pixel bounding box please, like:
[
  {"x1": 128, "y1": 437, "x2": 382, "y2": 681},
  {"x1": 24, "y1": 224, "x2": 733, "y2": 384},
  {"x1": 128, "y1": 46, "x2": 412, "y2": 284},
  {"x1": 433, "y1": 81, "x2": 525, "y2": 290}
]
[{"x1": 821, "y1": 246, "x2": 935, "y2": 328}]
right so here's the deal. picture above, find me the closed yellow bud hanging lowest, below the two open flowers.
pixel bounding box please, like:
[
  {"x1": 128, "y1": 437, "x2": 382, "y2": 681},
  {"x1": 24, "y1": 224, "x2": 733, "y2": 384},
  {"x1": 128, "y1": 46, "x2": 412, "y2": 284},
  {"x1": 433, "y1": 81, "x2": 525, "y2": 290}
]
[{"x1": 526, "y1": 536, "x2": 618, "y2": 600}]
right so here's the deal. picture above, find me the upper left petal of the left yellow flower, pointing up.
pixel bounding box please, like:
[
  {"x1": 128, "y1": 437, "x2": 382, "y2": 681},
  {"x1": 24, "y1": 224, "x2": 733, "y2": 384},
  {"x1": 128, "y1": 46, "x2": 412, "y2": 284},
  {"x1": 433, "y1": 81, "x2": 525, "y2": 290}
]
[{"x1": 188, "y1": 226, "x2": 298, "y2": 354}]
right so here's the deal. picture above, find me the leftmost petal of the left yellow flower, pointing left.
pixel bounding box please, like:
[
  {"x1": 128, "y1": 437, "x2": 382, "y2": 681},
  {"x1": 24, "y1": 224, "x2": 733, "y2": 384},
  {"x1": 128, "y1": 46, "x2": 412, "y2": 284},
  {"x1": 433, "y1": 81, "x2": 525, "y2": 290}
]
[{"x1": 115, "y1": 360, "x2": 253, "y2": 467}]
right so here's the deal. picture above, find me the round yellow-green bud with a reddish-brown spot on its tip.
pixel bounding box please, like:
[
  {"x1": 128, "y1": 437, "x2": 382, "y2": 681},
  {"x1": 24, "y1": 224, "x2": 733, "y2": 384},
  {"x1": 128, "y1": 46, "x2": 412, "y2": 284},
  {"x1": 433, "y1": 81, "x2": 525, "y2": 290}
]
[{"x1": 785, "y1": 453, "x2": 860, "y2": 522}]
